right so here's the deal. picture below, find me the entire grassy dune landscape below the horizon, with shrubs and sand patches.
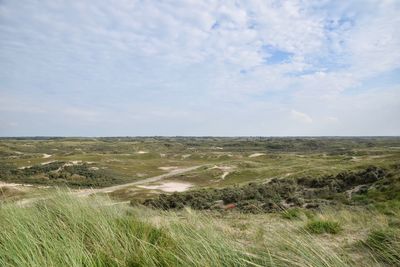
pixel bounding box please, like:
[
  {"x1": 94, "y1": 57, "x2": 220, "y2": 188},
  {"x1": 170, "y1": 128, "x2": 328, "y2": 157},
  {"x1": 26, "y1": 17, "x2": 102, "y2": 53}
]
[{"x1": 0, "y1": 137, "x2": 400, "y2": 266}]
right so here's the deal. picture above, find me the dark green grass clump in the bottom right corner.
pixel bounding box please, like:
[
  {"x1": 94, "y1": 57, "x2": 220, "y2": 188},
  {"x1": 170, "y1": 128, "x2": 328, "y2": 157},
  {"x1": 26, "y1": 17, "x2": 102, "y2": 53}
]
[{"x1": 363, "y1": 228, "x2": 400, "y2": 266}]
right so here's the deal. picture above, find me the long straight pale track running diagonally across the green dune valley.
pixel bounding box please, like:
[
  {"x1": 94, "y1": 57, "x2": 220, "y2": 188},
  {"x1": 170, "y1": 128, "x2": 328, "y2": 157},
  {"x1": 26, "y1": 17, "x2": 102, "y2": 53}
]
[{"x1": 74, "y1": 165, "x2": 203, "y2": 196}]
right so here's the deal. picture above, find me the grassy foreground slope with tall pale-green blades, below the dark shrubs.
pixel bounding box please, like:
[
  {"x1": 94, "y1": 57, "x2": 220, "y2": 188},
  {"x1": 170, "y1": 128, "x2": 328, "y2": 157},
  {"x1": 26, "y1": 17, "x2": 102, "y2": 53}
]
[{"x1": 0, "y1": 193, "x2": 400, "y2": 266}]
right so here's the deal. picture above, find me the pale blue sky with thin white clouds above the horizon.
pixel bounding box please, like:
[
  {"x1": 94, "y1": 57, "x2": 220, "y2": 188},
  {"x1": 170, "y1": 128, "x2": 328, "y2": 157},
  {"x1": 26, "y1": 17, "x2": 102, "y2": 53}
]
[{"x1": 0, "y1": 0, "x2": 400, "y2": 136}]
